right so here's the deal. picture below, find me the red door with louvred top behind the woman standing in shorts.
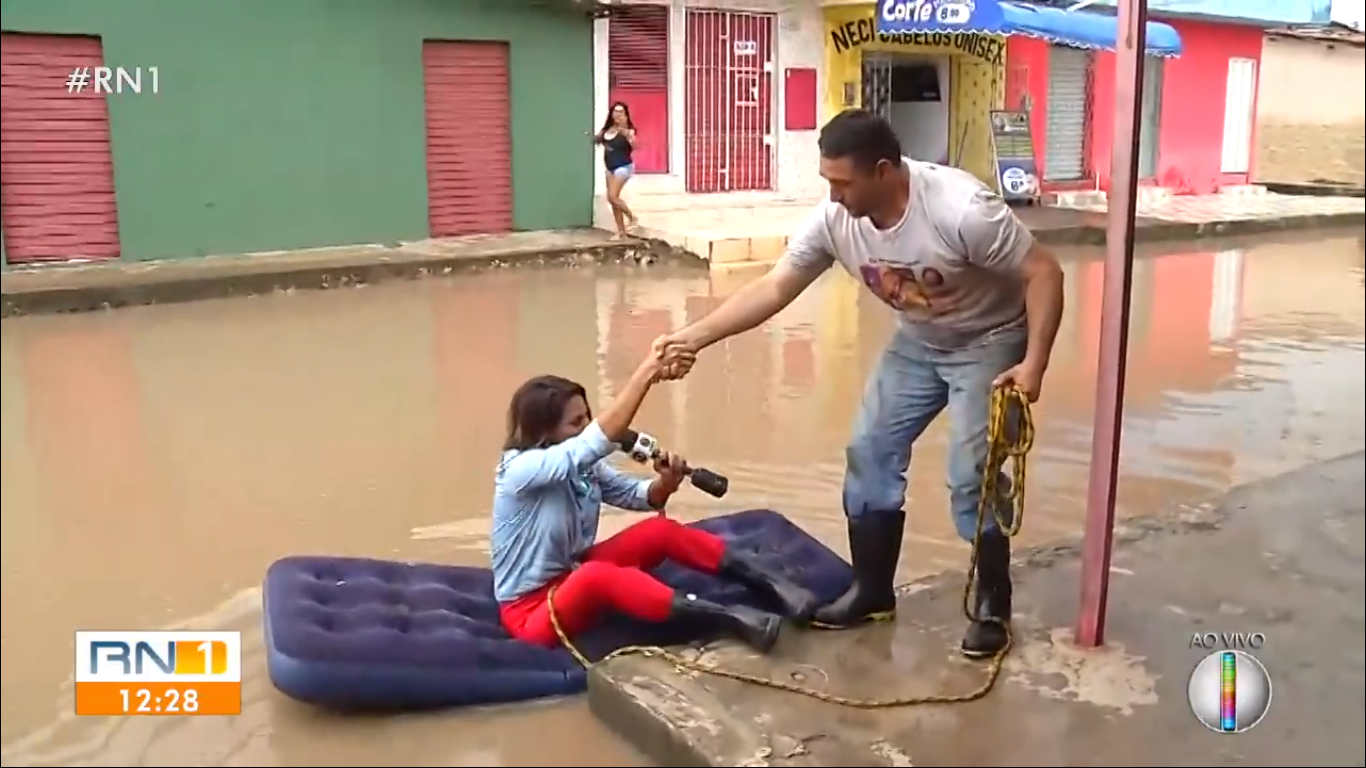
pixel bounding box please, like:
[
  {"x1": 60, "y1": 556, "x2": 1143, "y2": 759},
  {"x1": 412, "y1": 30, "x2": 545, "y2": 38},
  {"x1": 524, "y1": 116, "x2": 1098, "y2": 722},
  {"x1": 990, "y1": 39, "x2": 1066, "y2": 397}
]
[{"x1": 609, "y1": 5, "x2": 669, "y2": 174}]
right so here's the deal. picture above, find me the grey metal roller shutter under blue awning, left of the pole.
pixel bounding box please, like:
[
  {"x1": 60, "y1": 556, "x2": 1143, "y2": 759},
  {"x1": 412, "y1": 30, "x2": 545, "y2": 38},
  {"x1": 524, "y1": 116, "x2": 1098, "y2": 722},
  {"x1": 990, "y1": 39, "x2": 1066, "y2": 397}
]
[{"x1": 1044, "y1": 45, "x2": 1090, "y2": 182}]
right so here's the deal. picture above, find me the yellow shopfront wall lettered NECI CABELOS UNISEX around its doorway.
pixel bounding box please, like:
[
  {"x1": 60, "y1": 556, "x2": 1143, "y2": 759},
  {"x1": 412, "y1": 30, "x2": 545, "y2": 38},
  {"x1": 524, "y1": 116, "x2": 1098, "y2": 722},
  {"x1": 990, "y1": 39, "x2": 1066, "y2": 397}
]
[{"x1": 825, "y1": 3, "x2": 1005, "y2": 187}]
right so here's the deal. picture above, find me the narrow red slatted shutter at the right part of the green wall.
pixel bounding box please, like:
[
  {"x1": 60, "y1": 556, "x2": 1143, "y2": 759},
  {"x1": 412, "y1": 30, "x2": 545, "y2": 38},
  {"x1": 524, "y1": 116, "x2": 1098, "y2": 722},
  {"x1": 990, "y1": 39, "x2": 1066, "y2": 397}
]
[{"x1": 422, "y1": 41, "x2": 512, "y2": 238}]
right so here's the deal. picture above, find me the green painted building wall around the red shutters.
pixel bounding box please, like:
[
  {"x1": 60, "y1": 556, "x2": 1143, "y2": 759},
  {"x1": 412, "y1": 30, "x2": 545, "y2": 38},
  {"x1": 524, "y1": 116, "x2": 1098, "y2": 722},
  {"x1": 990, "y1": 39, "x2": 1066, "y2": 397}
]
[{"x1": 0, "y1": 0, "x2": 593, "y2": 261}]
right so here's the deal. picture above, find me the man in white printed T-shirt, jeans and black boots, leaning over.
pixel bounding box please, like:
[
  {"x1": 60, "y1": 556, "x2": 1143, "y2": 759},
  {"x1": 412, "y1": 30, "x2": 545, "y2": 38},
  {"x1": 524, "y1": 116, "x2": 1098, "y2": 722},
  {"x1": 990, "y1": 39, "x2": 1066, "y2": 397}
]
[{"x1": 644, "y1": 109, "x2": 1063, "y2": 657}]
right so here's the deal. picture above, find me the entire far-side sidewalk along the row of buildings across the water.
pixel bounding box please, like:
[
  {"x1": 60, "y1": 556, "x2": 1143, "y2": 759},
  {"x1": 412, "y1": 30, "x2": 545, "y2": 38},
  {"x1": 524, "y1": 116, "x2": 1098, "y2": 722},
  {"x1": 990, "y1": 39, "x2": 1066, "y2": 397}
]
[{"x1": 0, "y1": 195, "x2": 1366, "y2": 317}]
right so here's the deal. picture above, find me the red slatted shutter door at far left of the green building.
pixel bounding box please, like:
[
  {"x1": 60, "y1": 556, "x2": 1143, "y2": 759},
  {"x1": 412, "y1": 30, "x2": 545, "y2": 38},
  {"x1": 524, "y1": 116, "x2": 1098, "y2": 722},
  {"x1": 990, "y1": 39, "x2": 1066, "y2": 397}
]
[{"x1": 0, "y1": 34, "x2": 119, "y2": 264}]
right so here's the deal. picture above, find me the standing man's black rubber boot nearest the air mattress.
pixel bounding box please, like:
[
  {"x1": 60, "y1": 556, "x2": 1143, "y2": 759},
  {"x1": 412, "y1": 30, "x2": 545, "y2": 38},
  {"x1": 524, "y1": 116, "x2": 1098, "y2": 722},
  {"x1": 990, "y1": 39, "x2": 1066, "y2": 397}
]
[{"x1": 811, "y1": 510, "x2": 906, "y2": 629}]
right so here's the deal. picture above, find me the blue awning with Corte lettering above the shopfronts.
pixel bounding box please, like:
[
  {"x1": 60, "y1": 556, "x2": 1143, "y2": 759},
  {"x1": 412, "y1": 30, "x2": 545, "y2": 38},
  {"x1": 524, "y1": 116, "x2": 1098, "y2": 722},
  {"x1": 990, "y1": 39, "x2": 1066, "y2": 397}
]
[{"x1": 877, "y1": 0, "x2": 1182, "y2": 56}]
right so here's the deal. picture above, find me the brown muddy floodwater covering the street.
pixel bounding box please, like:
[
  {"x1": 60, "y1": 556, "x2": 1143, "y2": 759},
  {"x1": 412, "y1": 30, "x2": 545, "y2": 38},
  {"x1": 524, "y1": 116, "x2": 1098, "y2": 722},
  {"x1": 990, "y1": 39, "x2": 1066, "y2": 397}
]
[{"x1": 8, "y1": 236, "x2": 1366, "y2": 767}]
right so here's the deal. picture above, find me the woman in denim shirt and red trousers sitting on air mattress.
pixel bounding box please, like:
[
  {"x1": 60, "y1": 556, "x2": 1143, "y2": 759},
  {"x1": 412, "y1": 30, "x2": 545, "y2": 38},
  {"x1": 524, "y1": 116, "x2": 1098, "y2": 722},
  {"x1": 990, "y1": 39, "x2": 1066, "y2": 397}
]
[{"x1": 490, "y1": 344, "x2": 816, "y2": 652}]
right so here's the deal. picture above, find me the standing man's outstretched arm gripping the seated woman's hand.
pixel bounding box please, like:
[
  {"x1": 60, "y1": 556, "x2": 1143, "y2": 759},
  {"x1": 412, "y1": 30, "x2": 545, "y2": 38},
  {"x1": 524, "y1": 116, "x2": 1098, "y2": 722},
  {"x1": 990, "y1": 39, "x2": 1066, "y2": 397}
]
[{"x1": 654, "y1": 208, "x2": 835, "y2": 354}]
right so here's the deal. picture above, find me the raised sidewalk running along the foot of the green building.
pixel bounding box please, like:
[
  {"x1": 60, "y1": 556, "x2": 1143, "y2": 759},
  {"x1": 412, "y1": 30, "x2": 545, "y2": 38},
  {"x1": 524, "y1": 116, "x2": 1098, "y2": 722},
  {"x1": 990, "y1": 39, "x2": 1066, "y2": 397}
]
[{"x1": 0, "y1": 230, "x2": 665, "y2": 317}]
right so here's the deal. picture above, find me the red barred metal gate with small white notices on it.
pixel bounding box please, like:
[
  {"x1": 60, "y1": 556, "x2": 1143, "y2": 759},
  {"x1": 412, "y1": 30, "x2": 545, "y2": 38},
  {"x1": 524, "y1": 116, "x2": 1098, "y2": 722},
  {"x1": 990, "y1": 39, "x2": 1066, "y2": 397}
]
[{"x1": 684, "y1": 10, "x2": 775, "y2": 193}]
